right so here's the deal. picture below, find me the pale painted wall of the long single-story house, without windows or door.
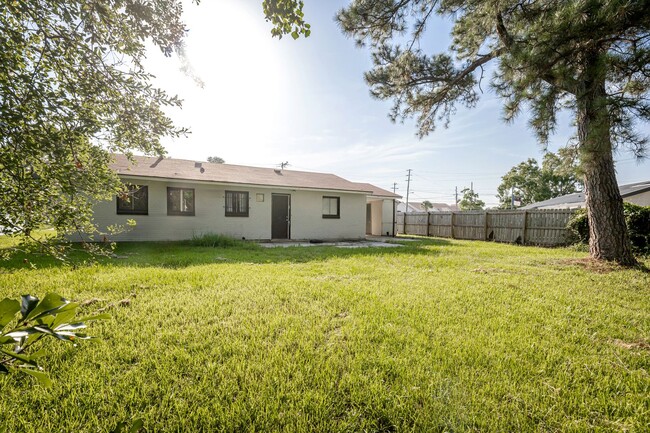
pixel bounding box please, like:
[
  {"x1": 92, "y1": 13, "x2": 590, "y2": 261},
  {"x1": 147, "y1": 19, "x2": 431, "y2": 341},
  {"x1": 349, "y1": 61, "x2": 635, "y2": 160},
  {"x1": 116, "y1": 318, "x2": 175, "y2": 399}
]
[{"x1": 89, "y1": 179, "x2": 366, "y2": 241}]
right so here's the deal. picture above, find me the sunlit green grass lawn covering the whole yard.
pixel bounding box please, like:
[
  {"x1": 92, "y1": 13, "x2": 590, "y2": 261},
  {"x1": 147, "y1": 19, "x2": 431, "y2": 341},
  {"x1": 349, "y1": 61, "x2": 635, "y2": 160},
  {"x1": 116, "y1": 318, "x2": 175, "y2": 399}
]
[{"x1": 0, "y1": 240, "x2": 650, "y2": 432}]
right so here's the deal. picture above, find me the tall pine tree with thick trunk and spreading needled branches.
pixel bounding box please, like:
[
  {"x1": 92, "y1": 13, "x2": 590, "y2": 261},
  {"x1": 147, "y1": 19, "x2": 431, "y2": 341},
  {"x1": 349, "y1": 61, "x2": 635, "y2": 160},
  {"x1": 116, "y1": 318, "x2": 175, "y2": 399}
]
[{"x1": 338, "y1": 0, "x2": 650, "y2": 265}]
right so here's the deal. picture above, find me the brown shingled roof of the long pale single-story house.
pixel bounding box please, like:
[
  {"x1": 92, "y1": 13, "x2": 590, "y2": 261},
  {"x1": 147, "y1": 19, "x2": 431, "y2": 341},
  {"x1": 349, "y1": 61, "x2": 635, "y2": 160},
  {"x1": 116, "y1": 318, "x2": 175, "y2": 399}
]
[{"x1": 111, "y1": 154, "x2": 380, "y2": 194}]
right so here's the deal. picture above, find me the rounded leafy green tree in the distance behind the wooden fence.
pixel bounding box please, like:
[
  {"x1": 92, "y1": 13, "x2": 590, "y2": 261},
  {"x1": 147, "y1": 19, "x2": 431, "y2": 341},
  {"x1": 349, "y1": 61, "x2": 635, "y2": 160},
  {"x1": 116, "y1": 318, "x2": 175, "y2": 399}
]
[{"x1": 497, "y1": 152, "x2": 580, "y2": 208}]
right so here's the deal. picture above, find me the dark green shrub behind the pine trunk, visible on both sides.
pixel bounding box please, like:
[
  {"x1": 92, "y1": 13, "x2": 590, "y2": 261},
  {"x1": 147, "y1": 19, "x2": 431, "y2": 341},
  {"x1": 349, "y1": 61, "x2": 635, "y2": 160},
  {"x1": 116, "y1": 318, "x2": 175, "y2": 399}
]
[{"x1": 567, "y1": 203, "x2": 650, "y2": 254}]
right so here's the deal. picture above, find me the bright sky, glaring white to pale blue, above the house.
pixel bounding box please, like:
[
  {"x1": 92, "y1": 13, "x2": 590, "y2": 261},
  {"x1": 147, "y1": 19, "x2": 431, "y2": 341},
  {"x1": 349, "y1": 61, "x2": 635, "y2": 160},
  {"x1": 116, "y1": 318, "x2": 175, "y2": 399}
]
[{"x1": 146, "y1": 0, "x2": 650, "y2": 205}]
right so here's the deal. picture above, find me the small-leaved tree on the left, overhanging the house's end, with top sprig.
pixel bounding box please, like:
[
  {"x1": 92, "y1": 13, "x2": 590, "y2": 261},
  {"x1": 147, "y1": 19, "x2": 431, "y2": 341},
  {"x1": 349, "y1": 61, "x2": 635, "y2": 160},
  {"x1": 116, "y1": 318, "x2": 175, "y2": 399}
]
[{"x1": 0, "y1": 0, "x2": 309, "y2": 253}]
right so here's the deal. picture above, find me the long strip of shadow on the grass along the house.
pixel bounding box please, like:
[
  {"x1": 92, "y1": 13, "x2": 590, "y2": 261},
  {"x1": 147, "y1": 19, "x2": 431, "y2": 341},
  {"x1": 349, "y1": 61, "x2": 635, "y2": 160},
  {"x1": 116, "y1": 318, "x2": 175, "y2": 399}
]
[{"x1": 0, "y1": 238, "x2": 456, "y2": 272}]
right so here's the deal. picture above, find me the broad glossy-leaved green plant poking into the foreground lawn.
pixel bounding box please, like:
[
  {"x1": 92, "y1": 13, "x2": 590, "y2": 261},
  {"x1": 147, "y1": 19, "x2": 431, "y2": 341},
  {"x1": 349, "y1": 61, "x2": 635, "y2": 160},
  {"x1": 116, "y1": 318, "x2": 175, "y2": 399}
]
[{"x1": 0, "y1": 293, "x2": 109, "y2": 386}]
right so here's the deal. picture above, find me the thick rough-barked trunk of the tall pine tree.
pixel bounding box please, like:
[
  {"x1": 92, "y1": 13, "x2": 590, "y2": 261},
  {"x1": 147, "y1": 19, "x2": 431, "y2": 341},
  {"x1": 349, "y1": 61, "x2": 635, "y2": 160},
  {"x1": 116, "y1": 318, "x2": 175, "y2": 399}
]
[{"x1": 576, "y1": 54, "x2": 637, "y2": 266}]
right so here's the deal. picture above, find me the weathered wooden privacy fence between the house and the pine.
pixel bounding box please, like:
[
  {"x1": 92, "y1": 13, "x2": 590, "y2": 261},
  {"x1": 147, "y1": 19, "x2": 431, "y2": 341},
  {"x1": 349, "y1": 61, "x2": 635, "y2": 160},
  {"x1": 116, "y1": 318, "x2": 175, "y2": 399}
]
[{"x1": 396, "y1": 209, "x2": 574, "y2": 246}]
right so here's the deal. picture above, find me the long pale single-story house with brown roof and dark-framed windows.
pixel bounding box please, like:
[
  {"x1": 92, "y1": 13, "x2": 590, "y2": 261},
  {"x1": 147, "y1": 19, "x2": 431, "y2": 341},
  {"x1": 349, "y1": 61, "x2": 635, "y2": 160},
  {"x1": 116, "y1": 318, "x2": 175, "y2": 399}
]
[{"x1": 86, "y1": 155, "x2": 399, "y2": 241}]
